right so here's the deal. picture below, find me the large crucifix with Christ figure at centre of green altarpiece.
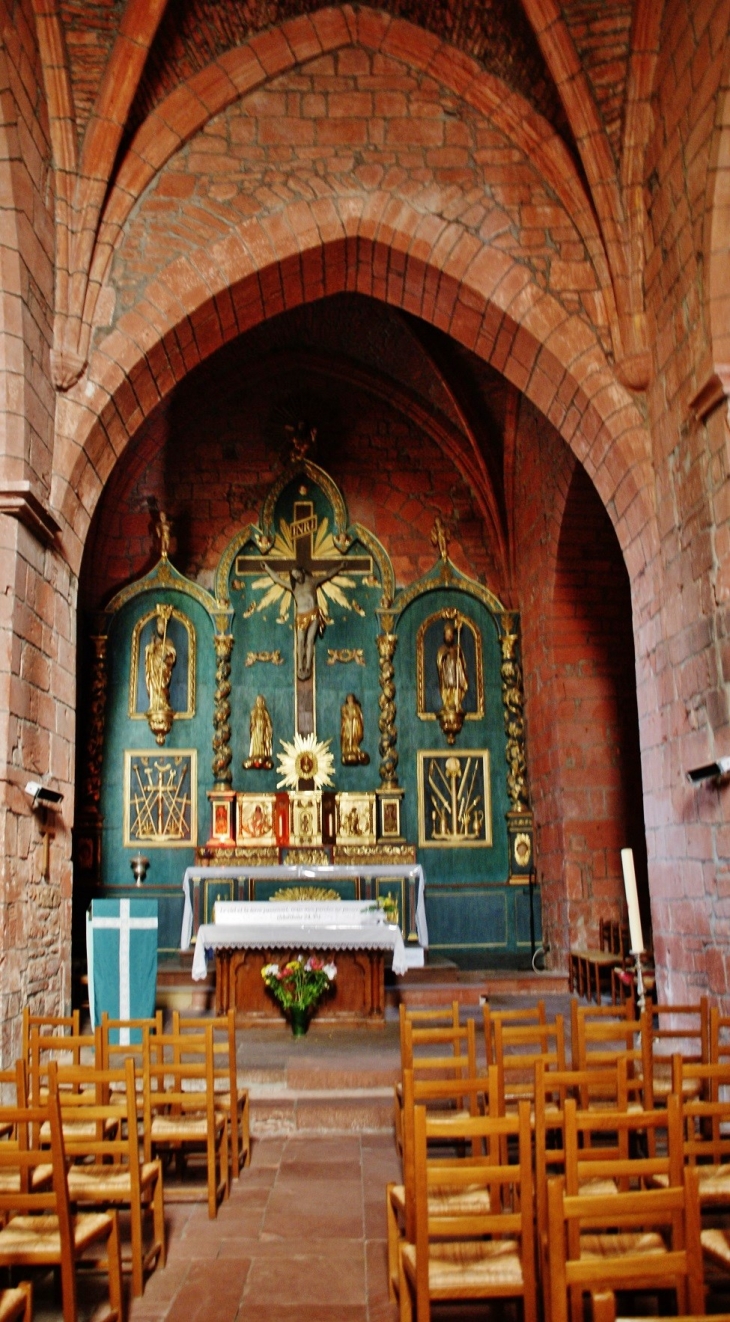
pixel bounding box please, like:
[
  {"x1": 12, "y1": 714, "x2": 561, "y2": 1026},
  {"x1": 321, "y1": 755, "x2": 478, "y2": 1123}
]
[{"x1": 235, "y1": 500, "x2": 373, "y2": 735}]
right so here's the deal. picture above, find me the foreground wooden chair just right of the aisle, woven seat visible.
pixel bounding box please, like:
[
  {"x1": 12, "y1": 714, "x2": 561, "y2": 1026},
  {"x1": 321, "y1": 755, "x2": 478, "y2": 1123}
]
[{"x1": 399, "y1": 1101, "x2": 537, "y2": 1322}]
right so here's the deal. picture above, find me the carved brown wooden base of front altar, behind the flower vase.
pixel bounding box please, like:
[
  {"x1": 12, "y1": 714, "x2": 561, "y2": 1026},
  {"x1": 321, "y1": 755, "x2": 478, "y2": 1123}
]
[{"x1": 216, "y1": 947, "x2": 385, "y2": 1027}]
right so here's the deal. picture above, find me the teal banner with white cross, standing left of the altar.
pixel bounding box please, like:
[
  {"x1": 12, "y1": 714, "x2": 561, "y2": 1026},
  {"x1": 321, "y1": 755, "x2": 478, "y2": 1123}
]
[{"x1": 86, "y1": 899, "x2": 157, "y2": 1046}]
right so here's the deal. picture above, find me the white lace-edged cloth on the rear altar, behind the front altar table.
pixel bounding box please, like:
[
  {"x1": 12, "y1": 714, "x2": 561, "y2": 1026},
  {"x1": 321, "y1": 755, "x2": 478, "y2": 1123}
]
[{"x1": 180, "y1": 863, "x2": 428, "y2": 951}]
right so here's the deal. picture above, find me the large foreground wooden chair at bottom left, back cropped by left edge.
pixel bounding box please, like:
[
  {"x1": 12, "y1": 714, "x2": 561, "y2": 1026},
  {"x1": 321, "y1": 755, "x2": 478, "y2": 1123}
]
[{"x1": 0, "y1": 1067, "x2": 123, "y2": 1322}]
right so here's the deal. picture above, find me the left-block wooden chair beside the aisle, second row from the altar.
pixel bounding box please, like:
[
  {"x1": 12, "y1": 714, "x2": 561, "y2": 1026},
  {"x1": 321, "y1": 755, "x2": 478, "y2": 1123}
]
[{"x1": 143, "y1": 1021, "x2": 229, "y2": 1219}]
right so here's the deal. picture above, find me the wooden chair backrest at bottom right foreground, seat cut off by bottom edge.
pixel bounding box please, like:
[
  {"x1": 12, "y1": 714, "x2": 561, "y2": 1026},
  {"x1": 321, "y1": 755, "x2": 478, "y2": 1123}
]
[{"x1": 548, "y1": 1167, "x2": 705, "y2": 1322}]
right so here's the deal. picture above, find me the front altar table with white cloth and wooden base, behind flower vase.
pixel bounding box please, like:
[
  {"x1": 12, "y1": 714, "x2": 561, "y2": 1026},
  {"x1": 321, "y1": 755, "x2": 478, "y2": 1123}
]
[{"x1": 193, "y1": 900, "x2": 407, "y2": 1025}]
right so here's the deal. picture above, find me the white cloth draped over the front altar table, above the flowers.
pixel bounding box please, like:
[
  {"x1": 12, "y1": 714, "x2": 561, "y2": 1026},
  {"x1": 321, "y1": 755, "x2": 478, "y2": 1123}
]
[{"x1": 193, "y1": 900, "x2": 409, "y2": 982}]
